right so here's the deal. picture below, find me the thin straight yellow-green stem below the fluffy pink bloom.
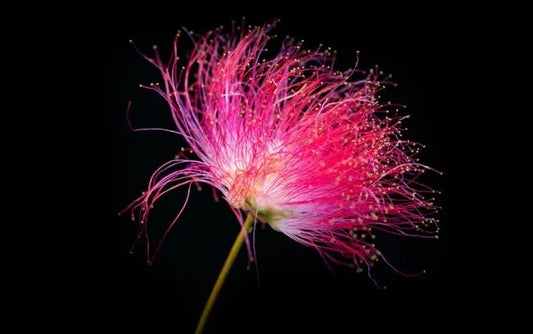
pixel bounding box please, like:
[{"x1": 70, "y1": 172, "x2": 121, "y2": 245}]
[{"x1": 195, "y1": 213, "x2": 254, "y2": 334}]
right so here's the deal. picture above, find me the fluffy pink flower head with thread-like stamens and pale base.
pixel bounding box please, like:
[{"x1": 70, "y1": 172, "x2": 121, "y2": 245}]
[{"x1": 122, "y1": 24, "x2": 437, "y2": 276}]
